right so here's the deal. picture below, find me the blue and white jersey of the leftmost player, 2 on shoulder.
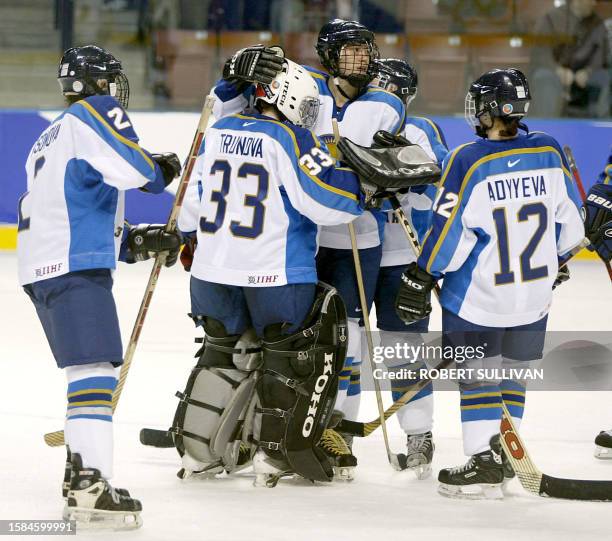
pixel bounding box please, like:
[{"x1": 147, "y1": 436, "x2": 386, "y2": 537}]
[{"x1": 17, "y1": 96, "x2": 164, "y2": 285}]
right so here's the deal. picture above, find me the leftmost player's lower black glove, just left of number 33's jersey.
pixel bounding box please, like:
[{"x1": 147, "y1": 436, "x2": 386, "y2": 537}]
[{"x1": 127, "y1": 224, "x2": 181, "y2": 267}]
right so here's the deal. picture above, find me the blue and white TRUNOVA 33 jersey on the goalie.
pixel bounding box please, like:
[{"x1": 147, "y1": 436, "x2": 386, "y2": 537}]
[{"x1": 178, "y1": 113, "x2": 363, "y2": 287}]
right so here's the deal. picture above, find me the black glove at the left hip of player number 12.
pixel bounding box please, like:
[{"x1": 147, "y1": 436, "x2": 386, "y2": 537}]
[{"x1": 395, "y1": 262, "x2": 435, "y2": 323}]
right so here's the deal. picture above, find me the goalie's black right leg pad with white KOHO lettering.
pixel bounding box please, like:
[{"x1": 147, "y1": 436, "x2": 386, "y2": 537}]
[{"x1": 258, "y1": 283, "x2": 347, "y2": 481}]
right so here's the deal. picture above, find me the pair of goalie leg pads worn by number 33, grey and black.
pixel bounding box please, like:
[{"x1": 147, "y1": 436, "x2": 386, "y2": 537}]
[{"x1": 170, "y1": 283, "x2": 347, "y2": 481}]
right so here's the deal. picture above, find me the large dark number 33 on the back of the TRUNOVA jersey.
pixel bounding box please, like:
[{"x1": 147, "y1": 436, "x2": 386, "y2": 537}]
[{"x1": 200, "y1": 160, "x2": 269, "y2": 239}]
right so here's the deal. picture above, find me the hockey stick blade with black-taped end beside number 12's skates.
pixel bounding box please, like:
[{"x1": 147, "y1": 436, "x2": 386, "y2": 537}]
[{"x1": 500, "y1": 402, "x2": 612, "y2": 502}]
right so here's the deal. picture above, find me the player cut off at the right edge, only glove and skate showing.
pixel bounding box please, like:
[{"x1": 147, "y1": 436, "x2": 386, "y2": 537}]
[{"x1": 584, "y1": 153, "x2": 612, "y2": 458}]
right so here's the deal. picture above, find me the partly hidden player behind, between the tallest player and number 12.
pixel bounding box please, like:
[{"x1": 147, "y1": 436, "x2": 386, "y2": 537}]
[{"x1": 373, "y1": 58, "x2": 448, "y2": 479}]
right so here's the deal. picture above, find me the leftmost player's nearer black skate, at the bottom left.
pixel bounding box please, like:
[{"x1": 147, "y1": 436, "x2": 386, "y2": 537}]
[{"x1": 63, "y1": 453, "x2": 142, "y2": 530}]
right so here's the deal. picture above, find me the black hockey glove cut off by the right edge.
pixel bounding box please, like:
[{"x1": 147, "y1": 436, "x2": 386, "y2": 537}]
[{"x1": 582, "y1": 184, "x2": 612, "y2": 261}]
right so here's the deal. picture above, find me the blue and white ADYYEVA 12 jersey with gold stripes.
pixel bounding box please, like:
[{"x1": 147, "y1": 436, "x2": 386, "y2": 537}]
[{"x1": 418, "y1": 132, "x2": 584, "y2": 327}]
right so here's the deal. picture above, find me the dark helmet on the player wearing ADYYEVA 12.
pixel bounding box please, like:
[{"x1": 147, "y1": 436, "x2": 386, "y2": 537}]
[{"x1": 465, "y1": 68, "x2": 531, "y2": 135}]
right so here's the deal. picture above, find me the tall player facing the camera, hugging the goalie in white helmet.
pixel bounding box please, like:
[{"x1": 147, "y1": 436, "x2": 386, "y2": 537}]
[{"x1": 204, "y1": 19, "x2": 405, "y2": 472}]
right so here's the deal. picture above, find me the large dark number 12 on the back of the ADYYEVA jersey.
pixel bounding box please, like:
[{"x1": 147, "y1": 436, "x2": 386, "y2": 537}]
[{"x1": 493, "y1": 203, "x2": 548, "y2": 286}]
